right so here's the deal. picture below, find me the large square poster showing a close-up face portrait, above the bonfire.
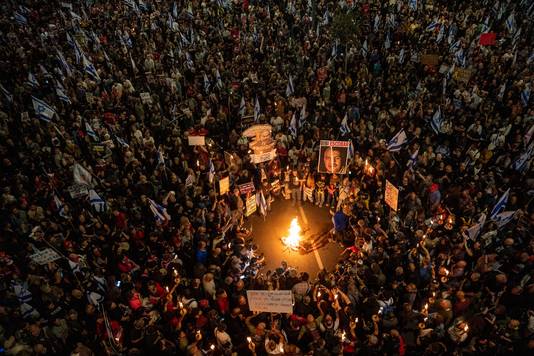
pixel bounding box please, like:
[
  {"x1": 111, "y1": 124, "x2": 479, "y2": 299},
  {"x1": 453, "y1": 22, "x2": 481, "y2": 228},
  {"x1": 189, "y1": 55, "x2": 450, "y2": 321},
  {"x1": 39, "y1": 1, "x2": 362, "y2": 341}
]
[{"x1": 317, "y1": 140, "x2": 350, "y2": 174}]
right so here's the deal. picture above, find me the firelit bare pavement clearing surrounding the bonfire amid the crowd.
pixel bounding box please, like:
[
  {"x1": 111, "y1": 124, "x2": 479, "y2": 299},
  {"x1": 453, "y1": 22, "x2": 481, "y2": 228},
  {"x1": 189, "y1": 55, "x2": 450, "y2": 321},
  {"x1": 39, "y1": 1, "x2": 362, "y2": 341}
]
[{"x1": 247, "y1": 200, "x2": 342, "y2": 278}]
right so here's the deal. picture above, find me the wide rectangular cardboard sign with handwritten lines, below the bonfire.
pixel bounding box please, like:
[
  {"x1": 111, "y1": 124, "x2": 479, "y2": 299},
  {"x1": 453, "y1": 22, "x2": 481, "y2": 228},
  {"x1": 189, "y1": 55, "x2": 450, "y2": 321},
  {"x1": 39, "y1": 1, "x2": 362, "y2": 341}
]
[{"x1": 247, "y1": 290, "x2": 293, "y2": 313}]
